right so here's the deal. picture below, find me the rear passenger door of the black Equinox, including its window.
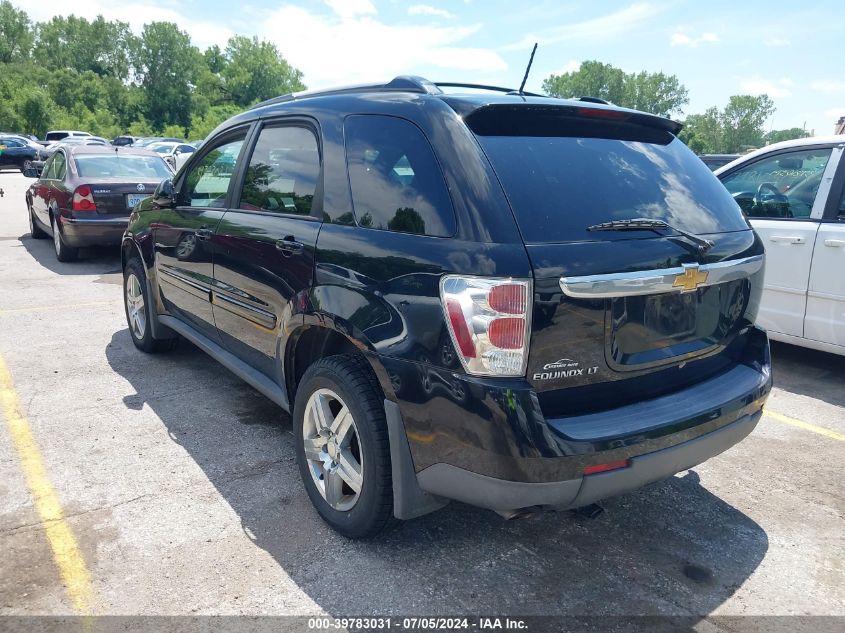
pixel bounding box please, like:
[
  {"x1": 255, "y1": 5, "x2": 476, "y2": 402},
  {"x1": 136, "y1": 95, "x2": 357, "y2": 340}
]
[{"x1": 212, "y1": 120, "x2": 322, "y2": 380}]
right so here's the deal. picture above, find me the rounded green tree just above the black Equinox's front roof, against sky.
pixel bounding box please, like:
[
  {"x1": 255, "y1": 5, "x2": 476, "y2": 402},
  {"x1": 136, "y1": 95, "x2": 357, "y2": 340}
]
[{"x1": 221, "y1": 35, "x2": 305, "y2": 106}]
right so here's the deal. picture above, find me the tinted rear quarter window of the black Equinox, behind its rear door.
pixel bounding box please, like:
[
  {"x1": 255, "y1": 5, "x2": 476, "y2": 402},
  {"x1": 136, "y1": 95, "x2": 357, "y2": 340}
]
[{"x1": 345, "y1": 115, "x2": 455, "y2": 237}]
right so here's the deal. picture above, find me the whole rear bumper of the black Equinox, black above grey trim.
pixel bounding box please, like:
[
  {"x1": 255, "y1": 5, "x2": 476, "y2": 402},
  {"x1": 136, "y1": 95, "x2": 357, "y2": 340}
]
[{"x1": 381, "y1": 328, "x2": 772, "y2": 510}]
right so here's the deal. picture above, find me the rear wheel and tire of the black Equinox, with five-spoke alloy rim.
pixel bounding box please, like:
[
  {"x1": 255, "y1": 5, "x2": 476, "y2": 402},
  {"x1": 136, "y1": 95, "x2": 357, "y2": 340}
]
[{"x1": 293, "y1": 355, "x2": 394, "y2": 539}]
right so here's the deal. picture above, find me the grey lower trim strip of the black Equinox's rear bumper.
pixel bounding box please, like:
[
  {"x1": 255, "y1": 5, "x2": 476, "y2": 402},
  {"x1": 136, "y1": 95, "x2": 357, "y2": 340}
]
[{"x1": 417, "y1": 411, "x2": 763, "y2": 510}]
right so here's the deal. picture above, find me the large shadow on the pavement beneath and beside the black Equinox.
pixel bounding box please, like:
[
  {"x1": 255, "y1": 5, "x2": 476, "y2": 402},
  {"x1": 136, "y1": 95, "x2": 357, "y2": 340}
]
[{"x1": 105, "y1": 330, "x2": 768, "y2": 617}]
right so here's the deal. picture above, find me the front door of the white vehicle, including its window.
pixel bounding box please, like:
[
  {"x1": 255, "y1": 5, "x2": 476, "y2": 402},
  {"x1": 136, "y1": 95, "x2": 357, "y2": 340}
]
[{"x1": 719, "y1": 146, "x2": 839, "y2": 338}]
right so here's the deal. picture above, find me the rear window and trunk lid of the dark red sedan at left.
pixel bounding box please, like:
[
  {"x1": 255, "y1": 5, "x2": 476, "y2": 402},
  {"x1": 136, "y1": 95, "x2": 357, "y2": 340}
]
[{"x1": 74, "y1": 151, "x2": 173, "y2": 217}]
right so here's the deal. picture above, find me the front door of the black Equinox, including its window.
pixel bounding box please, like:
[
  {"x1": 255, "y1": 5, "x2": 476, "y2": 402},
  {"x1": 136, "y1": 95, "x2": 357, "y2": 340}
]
[{"x1": 154, "y1": 128, "x2": 247, "y2": 343}]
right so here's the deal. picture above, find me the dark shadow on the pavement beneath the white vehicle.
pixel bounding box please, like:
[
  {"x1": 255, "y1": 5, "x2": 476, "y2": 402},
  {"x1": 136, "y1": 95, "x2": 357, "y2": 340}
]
[{"x1": 771, "y1": 341, "x2": 845, "y2": 407}]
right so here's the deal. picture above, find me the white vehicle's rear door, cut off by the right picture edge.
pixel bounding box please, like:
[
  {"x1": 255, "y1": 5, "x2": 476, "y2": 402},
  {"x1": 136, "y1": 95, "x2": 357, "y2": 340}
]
[{"x1": 804, "y1": 155, "x2": 845, "y2": 353}]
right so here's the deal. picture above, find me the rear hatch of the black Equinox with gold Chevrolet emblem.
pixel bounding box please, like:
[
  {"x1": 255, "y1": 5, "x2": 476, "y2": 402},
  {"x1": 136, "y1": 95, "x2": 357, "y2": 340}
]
[{"x1": 466, "y1": 105, "x2": 763, "y2": 415}]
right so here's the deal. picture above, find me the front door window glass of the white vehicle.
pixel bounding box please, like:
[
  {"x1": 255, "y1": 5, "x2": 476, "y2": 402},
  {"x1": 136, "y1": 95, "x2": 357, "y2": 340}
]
[{"x1": 722, "y1": 147, "x2": 831, "y2": 218}]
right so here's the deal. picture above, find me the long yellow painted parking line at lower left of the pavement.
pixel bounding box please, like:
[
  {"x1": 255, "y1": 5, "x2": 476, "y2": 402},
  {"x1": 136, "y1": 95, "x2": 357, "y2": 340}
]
[{"x1": 0, "y1": 356, "x2": 92, "y2": 615}]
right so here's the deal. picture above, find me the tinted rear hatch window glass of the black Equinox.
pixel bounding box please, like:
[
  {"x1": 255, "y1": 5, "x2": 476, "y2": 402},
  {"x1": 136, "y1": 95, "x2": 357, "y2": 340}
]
[{"x1": 478, "y1": 122, "x2": 748, "y2": 244}]
